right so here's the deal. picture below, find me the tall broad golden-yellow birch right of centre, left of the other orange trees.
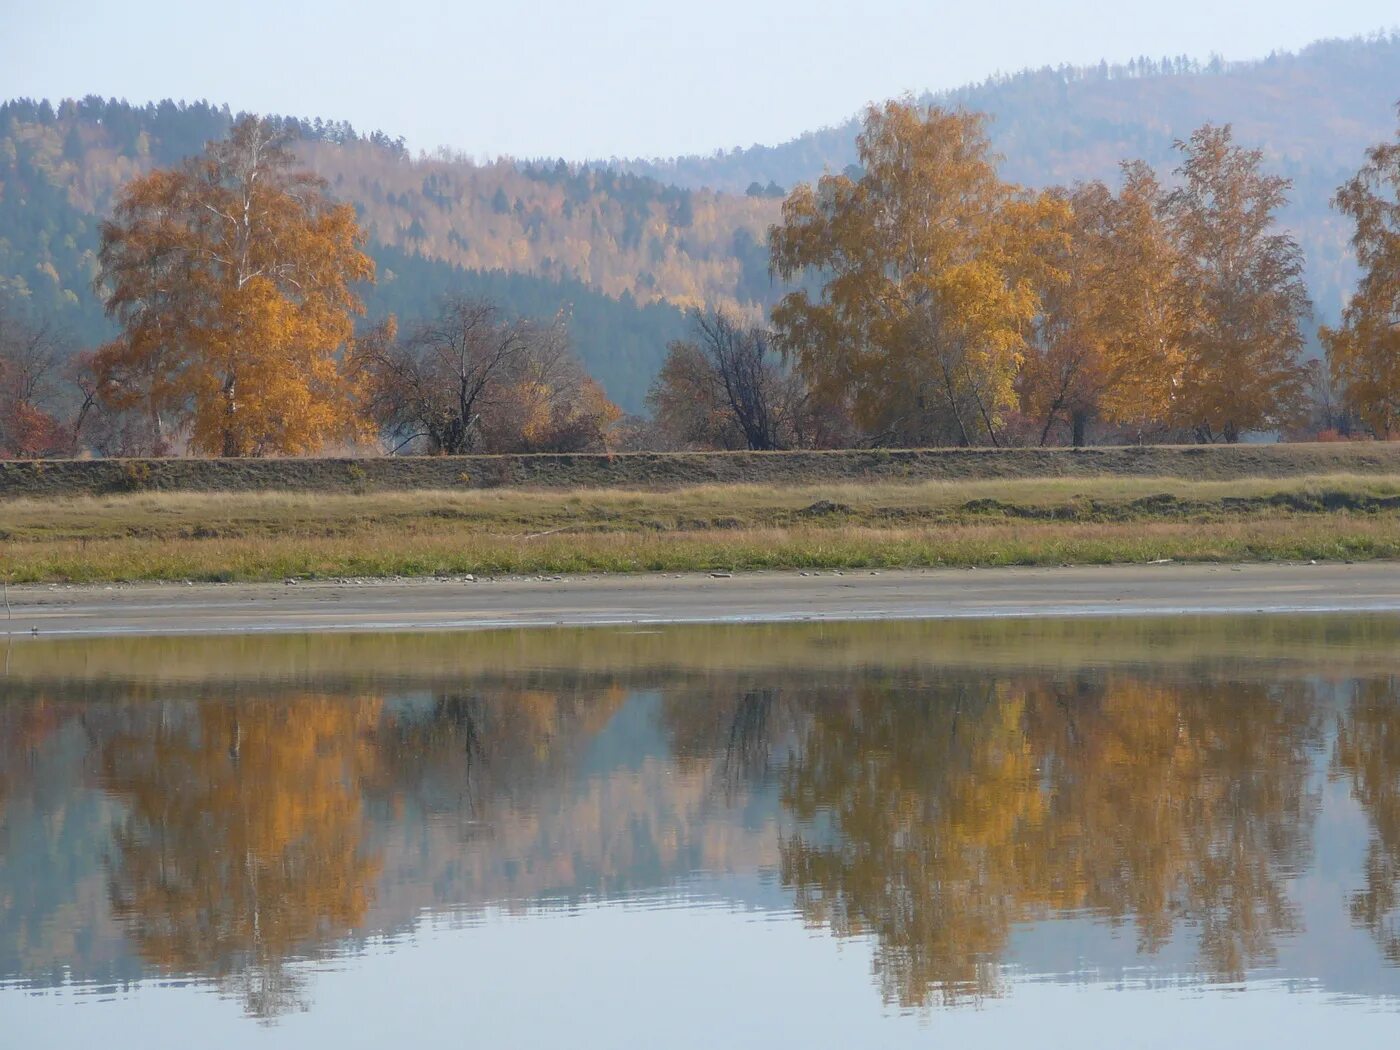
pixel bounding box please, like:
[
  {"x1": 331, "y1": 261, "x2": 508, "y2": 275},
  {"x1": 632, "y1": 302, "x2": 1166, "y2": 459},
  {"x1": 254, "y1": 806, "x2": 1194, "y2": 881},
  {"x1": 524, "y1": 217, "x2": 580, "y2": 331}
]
[{"x1": 769, "y1": 102, "x2": 1063, "y2": 445}]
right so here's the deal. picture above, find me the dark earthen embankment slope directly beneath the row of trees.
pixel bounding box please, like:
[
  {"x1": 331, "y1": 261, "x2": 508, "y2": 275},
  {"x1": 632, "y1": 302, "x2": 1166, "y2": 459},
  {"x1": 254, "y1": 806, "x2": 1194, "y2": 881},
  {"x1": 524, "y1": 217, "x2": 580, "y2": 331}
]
[{"x1": 0, "y1": 442, "x2": 1400, "y2": 500}]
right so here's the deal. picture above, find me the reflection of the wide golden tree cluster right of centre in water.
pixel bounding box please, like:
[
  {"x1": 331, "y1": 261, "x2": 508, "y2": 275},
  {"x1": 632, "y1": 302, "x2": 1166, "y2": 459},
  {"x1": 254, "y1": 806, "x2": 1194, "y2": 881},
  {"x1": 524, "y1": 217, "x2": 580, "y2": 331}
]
[{"x1": 781, "y1": 675, "x2": 1319, "y2": 1007}]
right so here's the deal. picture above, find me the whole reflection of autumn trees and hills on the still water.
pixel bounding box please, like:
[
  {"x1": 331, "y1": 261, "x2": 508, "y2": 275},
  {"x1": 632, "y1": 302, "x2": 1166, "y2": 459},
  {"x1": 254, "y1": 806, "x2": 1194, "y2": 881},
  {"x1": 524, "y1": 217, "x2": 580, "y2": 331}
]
[{"x1": 0, "y1": 620, "x2": 1400, "y2": 1036}]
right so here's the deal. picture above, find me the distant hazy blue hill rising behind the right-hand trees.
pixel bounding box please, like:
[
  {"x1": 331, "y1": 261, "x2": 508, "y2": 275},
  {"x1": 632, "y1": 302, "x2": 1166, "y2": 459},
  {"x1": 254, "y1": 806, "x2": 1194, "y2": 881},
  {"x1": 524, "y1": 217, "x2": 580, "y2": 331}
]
[{"x1": 610, "y1": 34, "x2": 1400, "y2": 316}]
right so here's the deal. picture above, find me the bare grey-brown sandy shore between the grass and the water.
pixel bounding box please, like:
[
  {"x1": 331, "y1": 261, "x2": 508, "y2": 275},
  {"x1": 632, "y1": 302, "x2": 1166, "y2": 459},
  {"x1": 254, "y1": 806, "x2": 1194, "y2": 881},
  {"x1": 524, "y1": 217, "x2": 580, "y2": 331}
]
[{"x1": 3, "y1": 561, "x2": 1400, "y2": 637}]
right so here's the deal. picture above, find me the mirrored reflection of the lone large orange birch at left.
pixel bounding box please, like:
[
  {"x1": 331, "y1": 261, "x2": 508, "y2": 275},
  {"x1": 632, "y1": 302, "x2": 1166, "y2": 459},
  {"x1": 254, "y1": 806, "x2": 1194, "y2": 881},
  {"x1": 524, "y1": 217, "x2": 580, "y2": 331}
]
[{"x1": 101, "y1": 694, "x2": 379, "y2": 1018}]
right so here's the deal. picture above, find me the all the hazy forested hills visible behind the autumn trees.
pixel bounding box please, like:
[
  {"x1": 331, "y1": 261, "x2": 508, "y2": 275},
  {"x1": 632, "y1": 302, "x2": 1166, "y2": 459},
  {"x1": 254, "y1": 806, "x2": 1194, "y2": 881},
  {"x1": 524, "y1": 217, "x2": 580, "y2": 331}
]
[{"x1": 0, "y1": 35, "x2": 1400, "y2": 410}]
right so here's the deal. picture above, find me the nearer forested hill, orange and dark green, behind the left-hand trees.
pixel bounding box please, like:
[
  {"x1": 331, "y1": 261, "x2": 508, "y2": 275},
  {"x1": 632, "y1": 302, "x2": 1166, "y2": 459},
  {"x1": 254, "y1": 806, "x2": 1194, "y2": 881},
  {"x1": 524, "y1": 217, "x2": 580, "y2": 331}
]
[{"x1": 0, "y1": 98, "x2": 733, "y2": 410}]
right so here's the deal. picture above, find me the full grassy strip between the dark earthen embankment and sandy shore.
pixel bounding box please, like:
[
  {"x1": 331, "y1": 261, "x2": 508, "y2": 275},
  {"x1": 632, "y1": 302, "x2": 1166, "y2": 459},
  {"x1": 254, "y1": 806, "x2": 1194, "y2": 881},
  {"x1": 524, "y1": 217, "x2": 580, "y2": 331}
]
[{"x1": 0, "y1": 475, "x2": 1400, "y2": 582}]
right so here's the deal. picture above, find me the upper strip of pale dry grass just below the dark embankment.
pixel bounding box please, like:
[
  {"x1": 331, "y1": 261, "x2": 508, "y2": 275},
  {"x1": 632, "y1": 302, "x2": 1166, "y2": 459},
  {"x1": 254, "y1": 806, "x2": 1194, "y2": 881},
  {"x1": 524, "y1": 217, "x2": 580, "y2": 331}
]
[{"x1": 8, "y1": 475, "x2": 1400, "y2": 539}]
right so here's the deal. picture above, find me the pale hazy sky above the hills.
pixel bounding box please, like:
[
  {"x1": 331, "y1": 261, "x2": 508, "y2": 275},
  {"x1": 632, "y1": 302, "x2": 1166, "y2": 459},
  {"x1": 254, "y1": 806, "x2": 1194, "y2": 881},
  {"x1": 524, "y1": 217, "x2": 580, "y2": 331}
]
[{"x1": 0, "y1": 0, "x2": 1400, "y2": 160}]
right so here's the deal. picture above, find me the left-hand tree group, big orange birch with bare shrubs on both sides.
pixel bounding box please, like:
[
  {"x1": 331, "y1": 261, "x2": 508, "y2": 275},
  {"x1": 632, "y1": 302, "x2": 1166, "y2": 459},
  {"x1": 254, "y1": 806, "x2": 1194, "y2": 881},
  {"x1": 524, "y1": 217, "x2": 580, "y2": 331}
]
[{"x1": 0, "y1": 118, "x2": 620, "y2": 456}]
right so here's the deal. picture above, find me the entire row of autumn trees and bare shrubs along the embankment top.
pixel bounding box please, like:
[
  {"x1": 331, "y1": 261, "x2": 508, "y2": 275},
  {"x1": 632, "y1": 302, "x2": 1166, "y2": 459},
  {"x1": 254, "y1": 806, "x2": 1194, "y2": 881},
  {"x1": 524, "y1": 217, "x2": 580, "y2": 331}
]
[{"x1": 0, "y1": 101, "x2": 1400, "y2": 456}]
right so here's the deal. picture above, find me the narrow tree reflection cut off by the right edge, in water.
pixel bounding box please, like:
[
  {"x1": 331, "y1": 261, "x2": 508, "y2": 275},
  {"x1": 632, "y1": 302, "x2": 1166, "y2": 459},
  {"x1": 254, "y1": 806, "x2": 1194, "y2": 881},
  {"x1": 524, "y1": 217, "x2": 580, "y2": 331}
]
[{"x1": 1333, "y1": 678, "x2": 1400, "y2": 963}]
